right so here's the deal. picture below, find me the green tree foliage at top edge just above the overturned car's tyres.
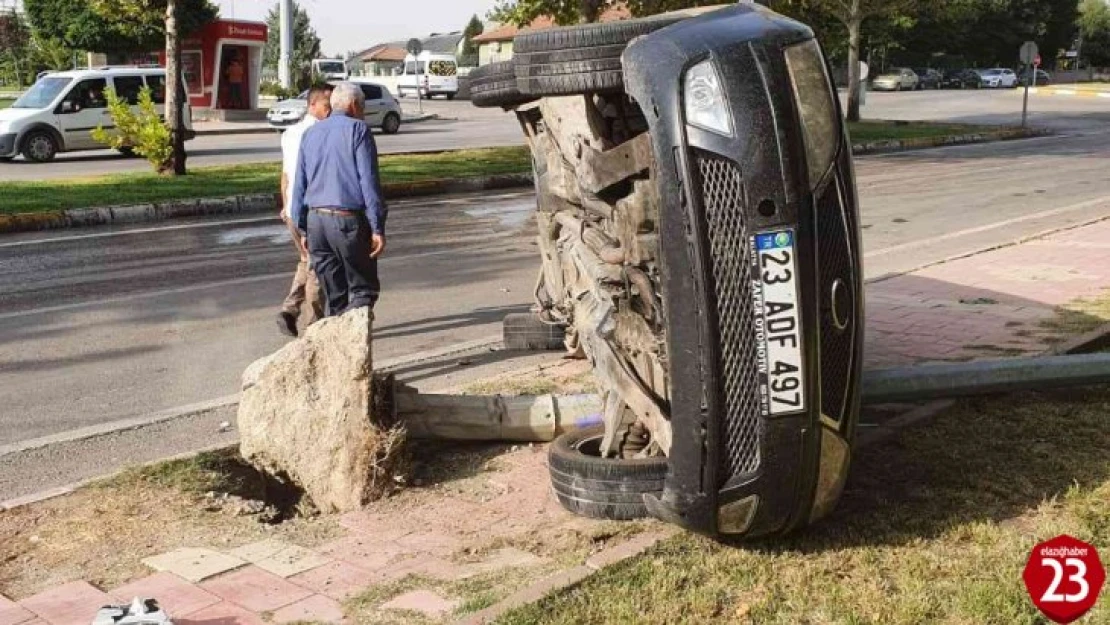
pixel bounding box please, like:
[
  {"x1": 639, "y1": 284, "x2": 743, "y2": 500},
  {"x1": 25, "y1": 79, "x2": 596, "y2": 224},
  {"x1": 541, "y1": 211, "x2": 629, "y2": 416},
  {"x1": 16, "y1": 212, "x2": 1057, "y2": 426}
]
[{"x1": 490, "y1": 0, "x2": 720, "y2": 26}]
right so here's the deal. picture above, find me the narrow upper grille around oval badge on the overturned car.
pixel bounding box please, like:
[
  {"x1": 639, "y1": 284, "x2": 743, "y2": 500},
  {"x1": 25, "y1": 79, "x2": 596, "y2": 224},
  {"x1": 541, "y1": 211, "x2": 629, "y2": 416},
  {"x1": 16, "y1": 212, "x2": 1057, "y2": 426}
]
[{"x1": 816, "y1": 180, "x2": 859, "y2": 423}]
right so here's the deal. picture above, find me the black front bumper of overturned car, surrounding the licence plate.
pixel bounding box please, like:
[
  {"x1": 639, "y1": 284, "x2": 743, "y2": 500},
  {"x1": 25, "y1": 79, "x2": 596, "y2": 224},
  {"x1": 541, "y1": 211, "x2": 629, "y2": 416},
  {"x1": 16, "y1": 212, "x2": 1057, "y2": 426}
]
[{"x1": 623, "y1": 4, "x2": 864, "y2": 536}]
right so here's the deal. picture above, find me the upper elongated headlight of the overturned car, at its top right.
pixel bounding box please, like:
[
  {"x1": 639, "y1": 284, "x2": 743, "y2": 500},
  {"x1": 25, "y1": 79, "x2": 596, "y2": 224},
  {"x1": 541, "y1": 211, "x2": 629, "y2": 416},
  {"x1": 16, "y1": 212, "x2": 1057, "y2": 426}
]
[{"x1": 786, "y1": 39, "x2": 840, "y2": 189}]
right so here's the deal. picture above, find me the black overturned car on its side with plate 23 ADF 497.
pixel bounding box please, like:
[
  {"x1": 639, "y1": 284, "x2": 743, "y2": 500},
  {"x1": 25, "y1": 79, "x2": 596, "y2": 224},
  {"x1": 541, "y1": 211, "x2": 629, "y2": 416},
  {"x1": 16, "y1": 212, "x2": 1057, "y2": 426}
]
[{"x1": 471, "y1": 3, "x2": 864, "y2": 536}]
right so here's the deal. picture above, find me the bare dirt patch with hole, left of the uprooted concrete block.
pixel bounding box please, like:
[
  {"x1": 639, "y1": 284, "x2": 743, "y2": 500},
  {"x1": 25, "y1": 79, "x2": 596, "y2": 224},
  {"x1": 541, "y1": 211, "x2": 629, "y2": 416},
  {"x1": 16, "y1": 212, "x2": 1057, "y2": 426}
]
[{"x1": 0, "y1": 452, "x2": 339, "y2": 599}]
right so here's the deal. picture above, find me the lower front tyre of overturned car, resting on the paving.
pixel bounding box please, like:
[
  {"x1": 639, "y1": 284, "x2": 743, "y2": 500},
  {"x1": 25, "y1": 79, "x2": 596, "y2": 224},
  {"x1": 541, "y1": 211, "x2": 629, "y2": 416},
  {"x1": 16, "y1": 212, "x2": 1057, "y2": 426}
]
[{"x1": 547, "y1": 426, "x2": 667, "y2": 521}]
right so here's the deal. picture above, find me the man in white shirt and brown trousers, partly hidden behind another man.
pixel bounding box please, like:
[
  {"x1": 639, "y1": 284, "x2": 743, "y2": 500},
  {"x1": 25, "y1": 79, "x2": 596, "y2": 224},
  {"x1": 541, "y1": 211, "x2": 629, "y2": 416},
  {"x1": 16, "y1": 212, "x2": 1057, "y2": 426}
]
[{"x1": 278, "y1": 84, "x2": 332, "y2": 336}]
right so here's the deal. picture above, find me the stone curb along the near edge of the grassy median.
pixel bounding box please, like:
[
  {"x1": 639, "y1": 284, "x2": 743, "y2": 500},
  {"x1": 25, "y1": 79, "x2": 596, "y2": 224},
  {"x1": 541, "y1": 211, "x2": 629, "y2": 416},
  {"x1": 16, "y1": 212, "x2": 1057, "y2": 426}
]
[{"x1": 0, "y1": 173, "x2": 533, "y2": 234}]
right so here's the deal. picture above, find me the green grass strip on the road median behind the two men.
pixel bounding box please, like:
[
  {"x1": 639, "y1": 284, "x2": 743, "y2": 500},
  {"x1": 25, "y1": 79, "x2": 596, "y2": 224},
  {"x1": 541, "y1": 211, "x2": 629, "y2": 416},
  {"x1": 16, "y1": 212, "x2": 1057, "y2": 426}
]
[{"x1": 0, "y1": 147, "x2": 532, "y2": 214}]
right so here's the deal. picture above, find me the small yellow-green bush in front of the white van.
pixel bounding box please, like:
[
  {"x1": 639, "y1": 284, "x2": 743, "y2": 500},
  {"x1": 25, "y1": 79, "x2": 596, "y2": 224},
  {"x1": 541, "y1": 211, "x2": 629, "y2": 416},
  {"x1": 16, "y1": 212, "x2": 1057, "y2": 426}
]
[{"x1": 92, "y1": 87, "x2": 173, "y2": 173}]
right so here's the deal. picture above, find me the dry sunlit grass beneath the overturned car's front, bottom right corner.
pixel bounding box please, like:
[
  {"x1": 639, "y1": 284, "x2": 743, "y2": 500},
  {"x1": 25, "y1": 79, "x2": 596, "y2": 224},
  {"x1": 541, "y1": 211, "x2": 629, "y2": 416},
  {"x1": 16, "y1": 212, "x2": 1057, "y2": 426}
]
[{"x1": 498, "y1": 387, "x2": 1110, "y2": 625}]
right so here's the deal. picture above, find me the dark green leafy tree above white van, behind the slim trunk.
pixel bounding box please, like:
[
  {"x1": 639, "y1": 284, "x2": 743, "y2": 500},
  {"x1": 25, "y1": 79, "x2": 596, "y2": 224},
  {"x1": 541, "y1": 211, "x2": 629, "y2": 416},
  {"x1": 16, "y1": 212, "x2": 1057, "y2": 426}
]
[{"x1": 23, "y1": 0, "x2": 219, "y2": 52}]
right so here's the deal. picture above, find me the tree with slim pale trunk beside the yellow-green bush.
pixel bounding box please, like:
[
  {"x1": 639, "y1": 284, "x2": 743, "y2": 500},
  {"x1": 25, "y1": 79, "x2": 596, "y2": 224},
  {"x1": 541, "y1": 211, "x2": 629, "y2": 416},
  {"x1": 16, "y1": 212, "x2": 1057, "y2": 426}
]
[{"x1": 88, "y1": 0, "x2": 218, "y2": 175}]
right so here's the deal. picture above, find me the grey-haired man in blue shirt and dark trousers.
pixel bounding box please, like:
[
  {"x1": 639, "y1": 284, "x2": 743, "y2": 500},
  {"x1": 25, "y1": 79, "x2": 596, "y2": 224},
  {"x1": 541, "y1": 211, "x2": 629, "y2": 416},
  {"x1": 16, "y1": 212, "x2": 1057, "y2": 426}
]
[{"x1": 290, "y1": 82, "x2": 387, "y2": 316}]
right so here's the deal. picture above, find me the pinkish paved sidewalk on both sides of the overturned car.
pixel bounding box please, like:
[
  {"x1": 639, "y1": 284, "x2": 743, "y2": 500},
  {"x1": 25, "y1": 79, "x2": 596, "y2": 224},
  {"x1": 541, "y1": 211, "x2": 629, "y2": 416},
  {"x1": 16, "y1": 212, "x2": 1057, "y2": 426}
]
[{"x1": 0, "y1": 221, "x2": 1110, "y2": 625}]
